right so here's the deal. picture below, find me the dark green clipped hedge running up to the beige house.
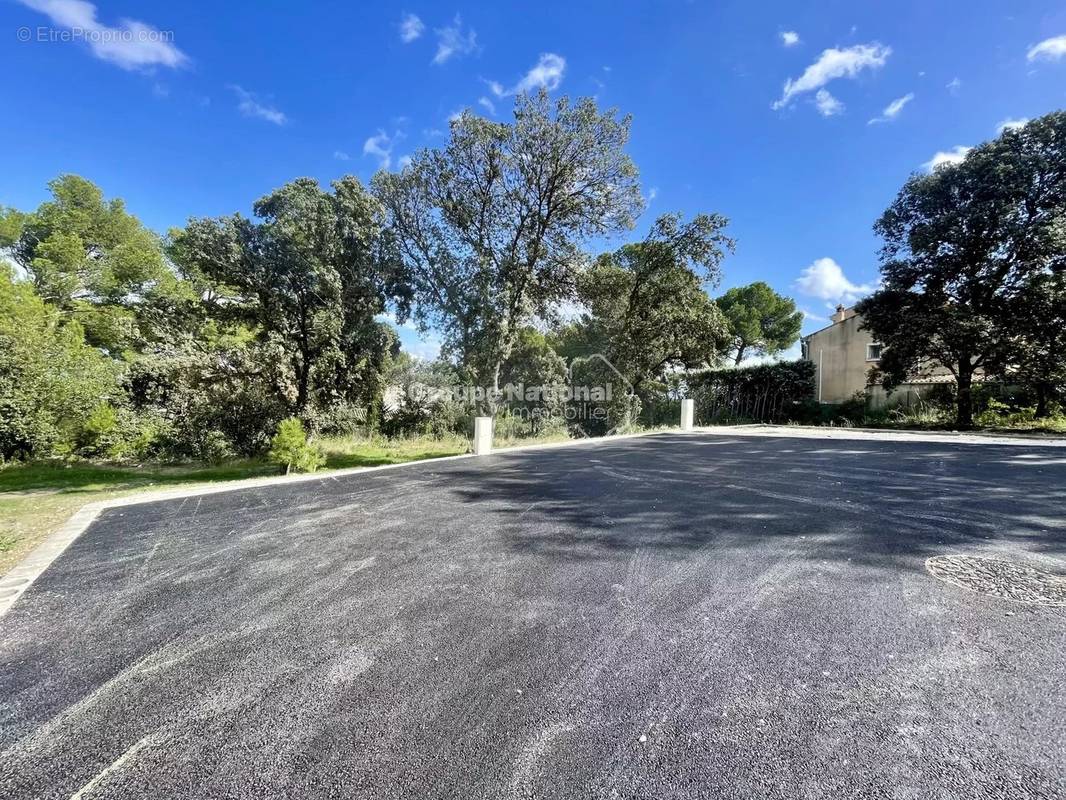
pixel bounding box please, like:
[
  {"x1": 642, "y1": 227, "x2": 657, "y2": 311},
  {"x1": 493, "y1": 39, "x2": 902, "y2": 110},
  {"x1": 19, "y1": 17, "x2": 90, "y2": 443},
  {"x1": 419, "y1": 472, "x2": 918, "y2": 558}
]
[{"x1": 688, "y1": 359, "x2": 814, "y2": 423}]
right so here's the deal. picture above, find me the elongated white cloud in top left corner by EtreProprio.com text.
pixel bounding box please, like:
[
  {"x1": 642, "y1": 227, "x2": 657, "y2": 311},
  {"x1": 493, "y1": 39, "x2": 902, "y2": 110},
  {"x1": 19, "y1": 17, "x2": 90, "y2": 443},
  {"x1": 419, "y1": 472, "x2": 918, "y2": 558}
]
[{"x1": 18, "y1": 0, "x2": 189, "y2": 69}]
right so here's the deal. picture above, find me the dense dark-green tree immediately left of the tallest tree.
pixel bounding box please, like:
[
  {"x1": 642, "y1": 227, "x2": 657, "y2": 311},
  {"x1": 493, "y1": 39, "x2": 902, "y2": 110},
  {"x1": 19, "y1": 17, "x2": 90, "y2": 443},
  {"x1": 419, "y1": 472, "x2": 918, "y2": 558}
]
[{"x1": 171, "y1": 176, "x2": 407, "y2": 415}]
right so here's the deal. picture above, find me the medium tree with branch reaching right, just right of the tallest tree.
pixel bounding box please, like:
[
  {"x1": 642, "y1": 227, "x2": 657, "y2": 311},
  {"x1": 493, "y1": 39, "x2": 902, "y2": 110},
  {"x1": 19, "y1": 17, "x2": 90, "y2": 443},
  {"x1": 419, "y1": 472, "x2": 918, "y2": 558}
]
[{"x1": 579, "y1": 214, "x2": 733, "y2": 390}]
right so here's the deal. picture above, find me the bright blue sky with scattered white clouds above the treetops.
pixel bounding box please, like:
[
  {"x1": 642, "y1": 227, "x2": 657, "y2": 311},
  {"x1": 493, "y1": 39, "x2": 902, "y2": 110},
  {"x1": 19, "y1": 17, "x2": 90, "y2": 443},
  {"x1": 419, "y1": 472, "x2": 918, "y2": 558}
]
[{"x1": 0, "y1": 0, "x2": 1066, "y2": 353}]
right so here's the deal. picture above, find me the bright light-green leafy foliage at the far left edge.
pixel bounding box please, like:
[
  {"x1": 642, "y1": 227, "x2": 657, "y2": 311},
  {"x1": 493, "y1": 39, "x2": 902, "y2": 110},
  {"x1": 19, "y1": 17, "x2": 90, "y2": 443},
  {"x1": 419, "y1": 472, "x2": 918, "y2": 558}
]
[{"x1": 0, "y1": 266, "x2": 120, "y2": 460}]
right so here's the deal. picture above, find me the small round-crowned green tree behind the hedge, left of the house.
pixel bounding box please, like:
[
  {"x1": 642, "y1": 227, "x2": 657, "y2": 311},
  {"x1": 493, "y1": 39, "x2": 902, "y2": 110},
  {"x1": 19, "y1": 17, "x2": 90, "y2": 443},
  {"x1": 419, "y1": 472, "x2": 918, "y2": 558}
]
[{"x1": 715, "y1": 281, "x2": 803, "y2": 367}]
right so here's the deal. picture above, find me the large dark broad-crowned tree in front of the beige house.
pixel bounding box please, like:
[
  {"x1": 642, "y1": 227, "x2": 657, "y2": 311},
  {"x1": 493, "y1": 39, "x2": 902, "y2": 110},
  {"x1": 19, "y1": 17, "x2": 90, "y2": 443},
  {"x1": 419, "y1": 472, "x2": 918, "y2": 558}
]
[{"x1": 856, "y1": 112, "x2": 1066, "y2": 428}]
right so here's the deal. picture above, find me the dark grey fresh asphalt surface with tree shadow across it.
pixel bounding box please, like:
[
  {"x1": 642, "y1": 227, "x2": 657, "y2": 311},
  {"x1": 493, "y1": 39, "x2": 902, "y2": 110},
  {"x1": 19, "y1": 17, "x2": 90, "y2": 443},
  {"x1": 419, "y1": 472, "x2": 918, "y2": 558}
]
[{"x1": 0, "y1": 434, "x2": 1066, "y2": 800}]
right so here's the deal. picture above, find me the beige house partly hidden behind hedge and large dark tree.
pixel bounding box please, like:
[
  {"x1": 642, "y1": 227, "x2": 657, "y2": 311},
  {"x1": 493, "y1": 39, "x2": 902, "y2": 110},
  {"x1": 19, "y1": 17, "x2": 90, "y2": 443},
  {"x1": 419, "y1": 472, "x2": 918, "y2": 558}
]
[{"x1": 801, "y1": 305, "x2": 954, "y2": 409}]
